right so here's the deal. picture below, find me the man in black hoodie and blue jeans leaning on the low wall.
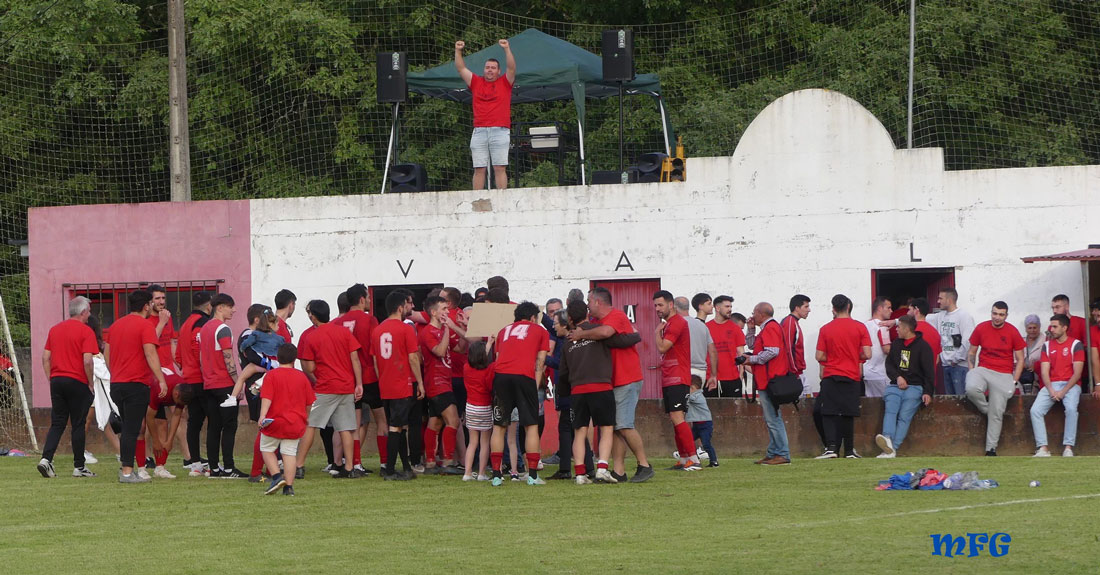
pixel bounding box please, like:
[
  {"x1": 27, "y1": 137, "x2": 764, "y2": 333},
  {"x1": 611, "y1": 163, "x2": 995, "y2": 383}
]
[{"x1": 875, "y1": 316, "x2": 936, "y2": 458}]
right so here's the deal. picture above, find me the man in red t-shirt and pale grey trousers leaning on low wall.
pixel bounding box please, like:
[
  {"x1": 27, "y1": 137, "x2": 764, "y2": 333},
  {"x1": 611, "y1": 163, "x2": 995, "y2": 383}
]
[{"x1": 966, "y1": 301, "x2": 1027, "y2": 455}]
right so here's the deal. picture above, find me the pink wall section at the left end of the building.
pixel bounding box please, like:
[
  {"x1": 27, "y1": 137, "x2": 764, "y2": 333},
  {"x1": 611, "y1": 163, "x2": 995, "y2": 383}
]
[{"x1": 29, "y1": 200, "x2": 252, "y2": 407}]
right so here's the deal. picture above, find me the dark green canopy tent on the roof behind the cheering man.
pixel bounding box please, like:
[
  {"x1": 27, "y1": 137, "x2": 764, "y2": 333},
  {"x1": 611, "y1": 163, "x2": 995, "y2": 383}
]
[{"x1": 394, "y1": 29, "x2": 672, "y2": 188}]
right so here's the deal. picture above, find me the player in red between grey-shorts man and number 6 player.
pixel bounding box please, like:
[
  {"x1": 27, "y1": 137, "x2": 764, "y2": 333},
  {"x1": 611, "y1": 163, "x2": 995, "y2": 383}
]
[{"x1": 332, "y1": 284, "x2": 386, "y2": 475}]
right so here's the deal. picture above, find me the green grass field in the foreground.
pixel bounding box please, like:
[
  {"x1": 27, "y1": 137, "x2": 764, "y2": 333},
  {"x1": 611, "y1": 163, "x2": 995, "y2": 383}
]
[{"x1": 0, "y1": 457, "x2": 1100, "y2": 575}]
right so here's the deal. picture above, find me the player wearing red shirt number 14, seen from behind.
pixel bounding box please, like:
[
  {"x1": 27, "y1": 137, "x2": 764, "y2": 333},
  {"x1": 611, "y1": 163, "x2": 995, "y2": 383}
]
[{"x1": 490, "y1": 301, "x2": 550, "y2": 487}]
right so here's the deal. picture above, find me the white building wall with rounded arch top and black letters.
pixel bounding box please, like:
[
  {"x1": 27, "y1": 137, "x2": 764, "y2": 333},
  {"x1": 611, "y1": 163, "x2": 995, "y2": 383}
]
[{"x1": 251, "y1": 90, "x2": 1100, "y2": 389}]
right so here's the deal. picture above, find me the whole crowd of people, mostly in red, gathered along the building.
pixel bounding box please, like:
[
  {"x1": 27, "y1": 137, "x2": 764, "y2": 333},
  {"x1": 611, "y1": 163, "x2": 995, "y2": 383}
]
[{"x1": 37, "y1": 276, "x2": 1100, "y2": 495}]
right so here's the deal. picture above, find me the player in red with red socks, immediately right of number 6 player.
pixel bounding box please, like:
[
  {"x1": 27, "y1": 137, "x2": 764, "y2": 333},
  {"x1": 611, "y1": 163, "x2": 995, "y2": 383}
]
[{"x1": 417, "y1": 296, "x2": 464, "y2": 475}]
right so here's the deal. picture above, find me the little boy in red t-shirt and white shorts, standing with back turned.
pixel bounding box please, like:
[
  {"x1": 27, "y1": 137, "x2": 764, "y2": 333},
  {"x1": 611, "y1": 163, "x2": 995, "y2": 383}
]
[{"x1": 260, "y1": 343, "x2": 317, "y2": 496}]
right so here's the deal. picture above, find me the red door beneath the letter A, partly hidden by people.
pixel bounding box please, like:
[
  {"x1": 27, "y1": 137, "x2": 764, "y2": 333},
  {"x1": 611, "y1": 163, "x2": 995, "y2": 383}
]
[{"x1": 592, "y1": 279, "x2": 661, "y2": 399}]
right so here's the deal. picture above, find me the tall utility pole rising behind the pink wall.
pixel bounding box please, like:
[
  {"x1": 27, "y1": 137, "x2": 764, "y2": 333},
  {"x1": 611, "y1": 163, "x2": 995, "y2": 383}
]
[{"x1": 168, "y1": 0, "x2": 191, "y2": 201}]
